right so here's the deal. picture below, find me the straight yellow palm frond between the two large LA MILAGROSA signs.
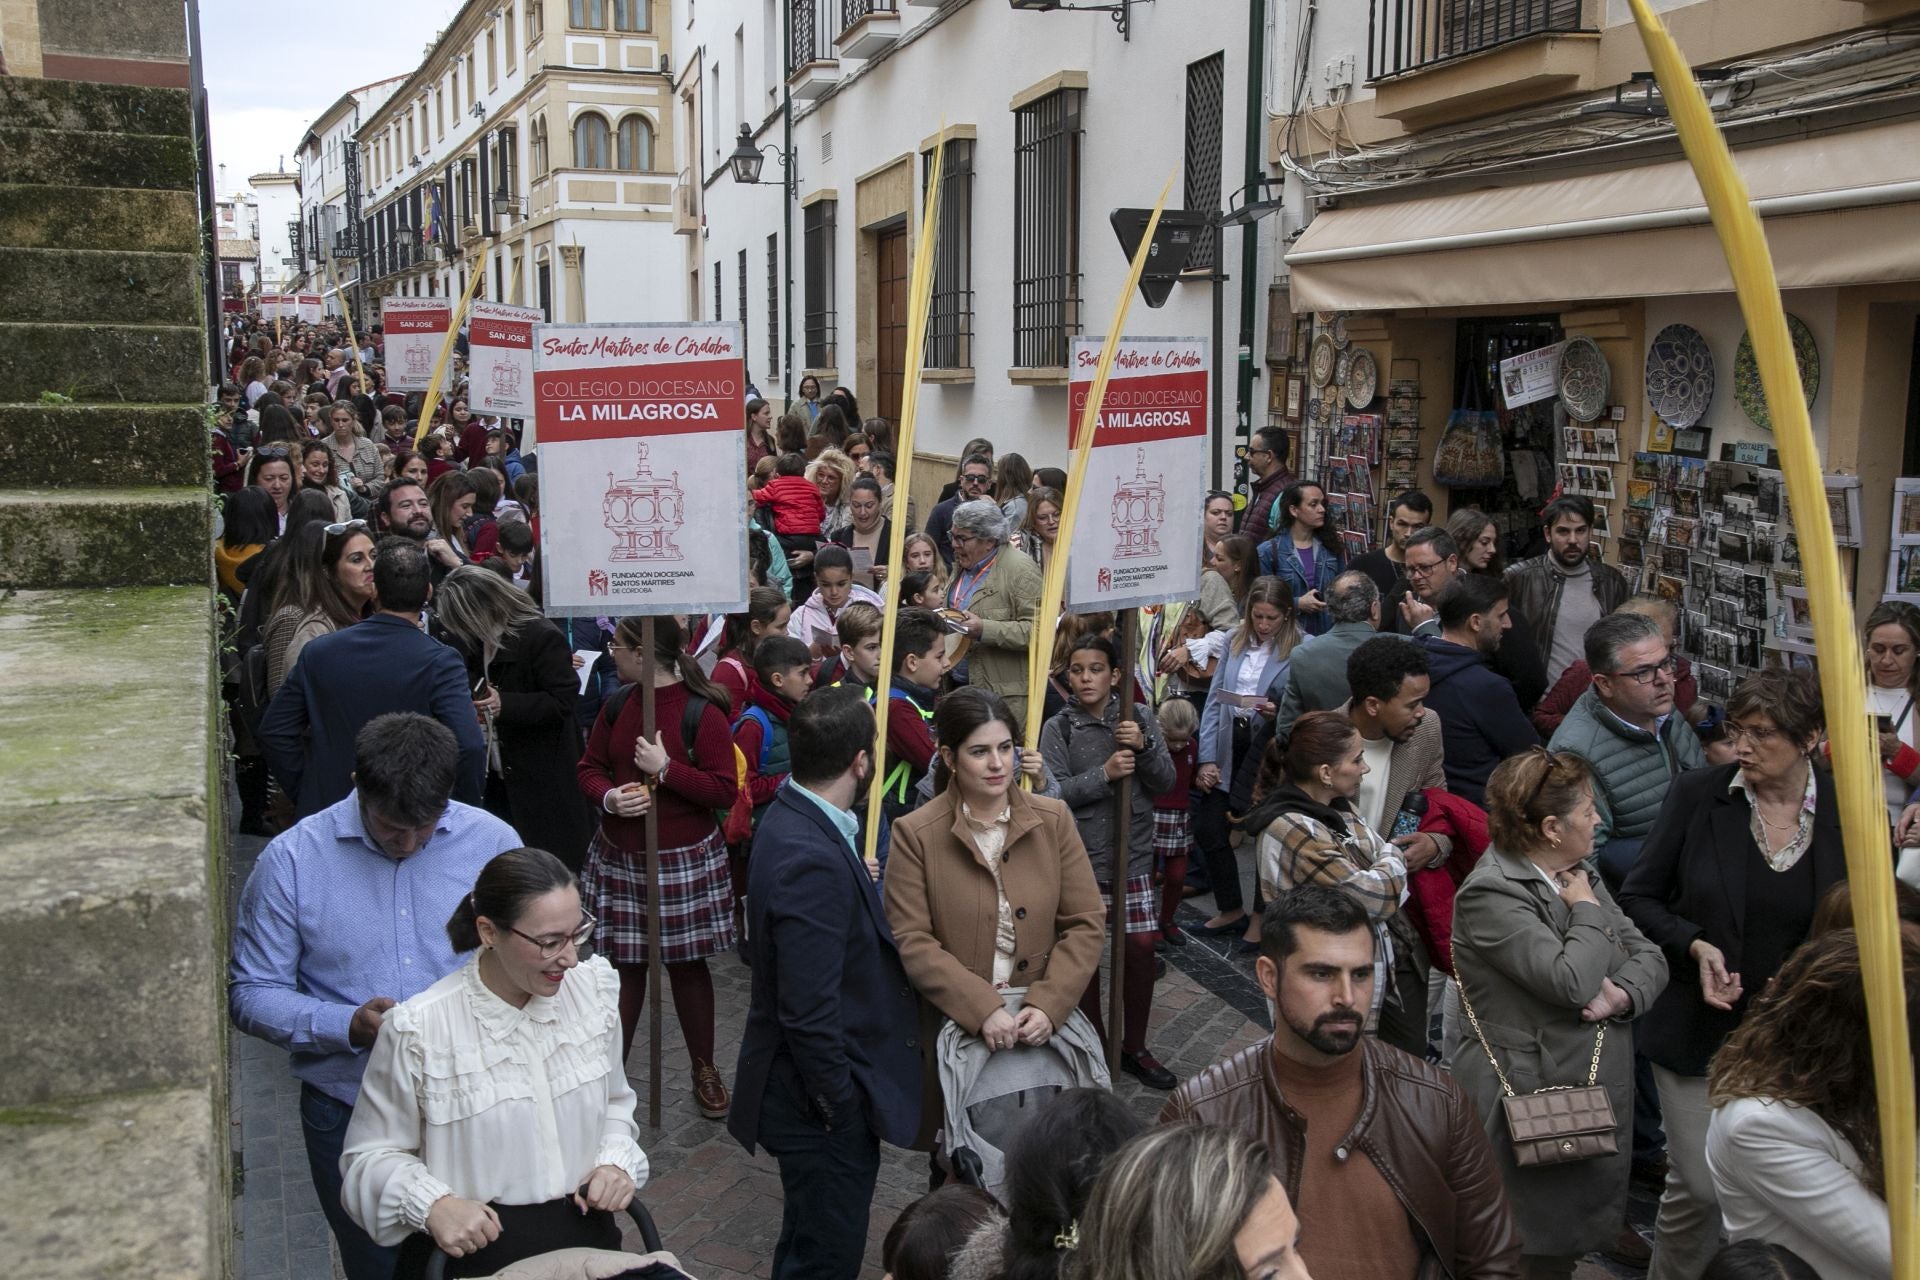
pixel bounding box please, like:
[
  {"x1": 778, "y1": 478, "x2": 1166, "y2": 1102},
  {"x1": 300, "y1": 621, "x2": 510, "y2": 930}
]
[{"x1": 860, "y1": 130, "x2": 947, "y2": 879}]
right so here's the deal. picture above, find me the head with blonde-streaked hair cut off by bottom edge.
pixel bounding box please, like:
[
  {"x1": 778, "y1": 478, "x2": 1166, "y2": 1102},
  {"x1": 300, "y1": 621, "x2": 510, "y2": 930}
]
[{"x1": 1066, "y1": 1125, "x2": 1311, "y2": 1280}]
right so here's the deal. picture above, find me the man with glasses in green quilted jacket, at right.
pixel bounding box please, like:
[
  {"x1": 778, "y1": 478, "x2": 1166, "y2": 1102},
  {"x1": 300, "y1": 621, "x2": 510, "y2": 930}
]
[{"x1": 1549, "y1": 612, "x2": 1707, "y2": 892}]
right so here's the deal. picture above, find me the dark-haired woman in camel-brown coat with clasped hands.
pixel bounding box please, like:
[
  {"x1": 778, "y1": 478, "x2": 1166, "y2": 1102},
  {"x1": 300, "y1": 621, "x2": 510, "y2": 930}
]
[{"x1": 885, "y1": 689, "x2": 1106, "y2": 1136}]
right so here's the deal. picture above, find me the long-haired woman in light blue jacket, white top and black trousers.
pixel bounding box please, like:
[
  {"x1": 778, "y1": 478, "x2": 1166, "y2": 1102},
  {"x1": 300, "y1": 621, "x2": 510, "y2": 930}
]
[{"x1": 1194, "y1": 579, "x2": 1300, "y2": 952}]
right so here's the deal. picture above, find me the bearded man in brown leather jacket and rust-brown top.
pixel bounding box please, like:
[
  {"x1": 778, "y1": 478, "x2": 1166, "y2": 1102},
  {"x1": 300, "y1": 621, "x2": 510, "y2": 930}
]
[{"x1": 1160, "y1": 885, "x2": 1521, "y2": 1280}]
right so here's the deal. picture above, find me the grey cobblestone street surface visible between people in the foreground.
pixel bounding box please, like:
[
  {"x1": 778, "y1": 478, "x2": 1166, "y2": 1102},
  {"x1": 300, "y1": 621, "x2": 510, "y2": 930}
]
[{"x1": 232, "y1": 837, "x2": 1651, "y2": 1280}]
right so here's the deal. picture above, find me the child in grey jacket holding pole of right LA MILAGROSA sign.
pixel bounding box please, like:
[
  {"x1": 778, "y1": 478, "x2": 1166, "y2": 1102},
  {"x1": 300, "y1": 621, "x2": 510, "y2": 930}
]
[{"x1": 1041, "y1": 631, "x2": 1179, "y2": 1090}]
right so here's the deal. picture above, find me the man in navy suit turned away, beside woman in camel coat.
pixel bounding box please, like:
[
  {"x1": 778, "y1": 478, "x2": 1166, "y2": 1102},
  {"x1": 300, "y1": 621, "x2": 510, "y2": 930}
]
[{"x1": 728, "y1": 687, "x2": 922, "y2": 1280}]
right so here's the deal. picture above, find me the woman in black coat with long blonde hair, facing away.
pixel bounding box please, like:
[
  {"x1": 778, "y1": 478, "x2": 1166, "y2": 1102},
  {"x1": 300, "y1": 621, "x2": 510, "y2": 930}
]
[{"x1": 434, "y1": 564, "x2": 593, "y2": 873}]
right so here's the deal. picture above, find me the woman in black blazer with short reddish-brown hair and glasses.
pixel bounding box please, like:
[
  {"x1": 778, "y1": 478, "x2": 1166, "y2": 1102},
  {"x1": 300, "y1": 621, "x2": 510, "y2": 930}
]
[{"x1": 1620, "y1": 670, "x2": 1847, "y2": 1280}]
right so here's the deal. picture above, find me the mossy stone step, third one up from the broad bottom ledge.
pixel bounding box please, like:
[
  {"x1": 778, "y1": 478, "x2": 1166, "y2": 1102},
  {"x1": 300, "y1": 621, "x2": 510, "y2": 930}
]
[{"x1": 0, "y1": 322, "x2": 209, "y2": 401}]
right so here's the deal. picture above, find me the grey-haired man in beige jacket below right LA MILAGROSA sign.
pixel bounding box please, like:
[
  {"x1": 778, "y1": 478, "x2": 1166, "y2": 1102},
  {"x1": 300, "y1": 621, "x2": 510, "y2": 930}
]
[{"x1": 947, "y1": 499, "x2": 1041, "y2": 723}]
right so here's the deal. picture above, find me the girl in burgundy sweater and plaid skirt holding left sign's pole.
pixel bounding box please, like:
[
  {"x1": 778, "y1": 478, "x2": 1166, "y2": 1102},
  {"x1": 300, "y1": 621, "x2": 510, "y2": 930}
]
[{"x1": 580, "y1": 616, "x2": 735, "y2": 1121}]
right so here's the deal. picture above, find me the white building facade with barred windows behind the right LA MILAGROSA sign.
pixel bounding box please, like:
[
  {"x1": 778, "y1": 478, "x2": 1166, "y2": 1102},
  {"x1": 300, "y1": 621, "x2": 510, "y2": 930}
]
[{"x1": 676, "y1": 0, "x2": 1279, "y2": 472}]
